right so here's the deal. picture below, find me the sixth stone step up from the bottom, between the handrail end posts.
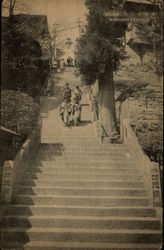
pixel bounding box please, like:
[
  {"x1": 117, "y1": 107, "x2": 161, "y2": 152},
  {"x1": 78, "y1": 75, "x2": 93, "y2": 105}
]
[{"x1": 17, "y1": 186, "x2": 147, "y2": 197}]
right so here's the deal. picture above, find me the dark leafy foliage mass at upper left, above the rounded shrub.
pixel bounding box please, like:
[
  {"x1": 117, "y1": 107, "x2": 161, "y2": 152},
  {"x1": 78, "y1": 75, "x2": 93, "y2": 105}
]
[{"x1": 2, "y1": 17, "x2": 49, "y2": 99}]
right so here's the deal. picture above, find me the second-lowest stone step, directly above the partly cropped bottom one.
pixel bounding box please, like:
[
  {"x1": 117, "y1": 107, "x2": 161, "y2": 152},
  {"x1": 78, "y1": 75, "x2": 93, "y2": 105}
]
[{"x1": 0, "y1": 227, "x2": 161, "y2": 244}]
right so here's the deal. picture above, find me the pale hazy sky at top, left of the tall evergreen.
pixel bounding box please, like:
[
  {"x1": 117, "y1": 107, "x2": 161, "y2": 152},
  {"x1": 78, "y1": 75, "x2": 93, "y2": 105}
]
[{"x1": 2, "y1": 0, "x2": 86, "y2": 40}]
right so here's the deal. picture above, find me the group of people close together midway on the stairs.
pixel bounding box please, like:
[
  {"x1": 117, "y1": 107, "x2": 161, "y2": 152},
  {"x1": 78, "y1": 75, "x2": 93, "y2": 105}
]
[{"x1": 60, "y1": 83, "x2": 82, "y2": 126}]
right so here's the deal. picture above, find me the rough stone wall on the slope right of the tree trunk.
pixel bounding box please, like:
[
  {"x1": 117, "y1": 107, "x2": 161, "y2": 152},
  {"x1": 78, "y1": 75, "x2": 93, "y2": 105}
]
[{"x1": 114, "y1": 46, "x2": 163, "y2": 160}]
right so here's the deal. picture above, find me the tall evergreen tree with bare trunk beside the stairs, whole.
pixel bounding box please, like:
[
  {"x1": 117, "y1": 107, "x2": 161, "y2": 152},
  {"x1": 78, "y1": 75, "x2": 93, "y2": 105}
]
[{"x1": 76, "y1": 0, "x2": 126, "y2": 137}]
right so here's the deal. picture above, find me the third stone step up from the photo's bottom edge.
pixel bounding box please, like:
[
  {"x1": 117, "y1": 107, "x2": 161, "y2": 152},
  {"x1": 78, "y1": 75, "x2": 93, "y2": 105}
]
[{"x1": 1, "y1": 215, "x2": 161, "y2": 230}]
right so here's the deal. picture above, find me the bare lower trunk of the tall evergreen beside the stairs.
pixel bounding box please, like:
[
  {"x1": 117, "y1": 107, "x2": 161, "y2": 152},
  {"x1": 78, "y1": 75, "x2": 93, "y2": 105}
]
[{"x1": 99, "y1": 64, "x2": 117, "y2": 137}]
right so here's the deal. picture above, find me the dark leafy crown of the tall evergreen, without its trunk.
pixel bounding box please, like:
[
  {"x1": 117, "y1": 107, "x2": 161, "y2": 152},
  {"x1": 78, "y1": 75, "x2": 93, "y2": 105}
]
[{"x1": 76, "y1": 0, "x2": 126, "y2": 84}]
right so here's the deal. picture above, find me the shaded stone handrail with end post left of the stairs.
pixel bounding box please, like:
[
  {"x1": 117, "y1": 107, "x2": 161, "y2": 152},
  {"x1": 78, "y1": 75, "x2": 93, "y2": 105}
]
[{"x1": 1, "y1": 119, "x2": 41, "y2": 205}]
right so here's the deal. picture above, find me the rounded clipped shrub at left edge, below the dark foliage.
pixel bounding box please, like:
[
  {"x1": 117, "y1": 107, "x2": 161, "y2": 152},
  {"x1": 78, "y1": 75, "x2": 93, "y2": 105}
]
[{"x1": 1, "y1": 90, "x2": 39, "y2": 137}]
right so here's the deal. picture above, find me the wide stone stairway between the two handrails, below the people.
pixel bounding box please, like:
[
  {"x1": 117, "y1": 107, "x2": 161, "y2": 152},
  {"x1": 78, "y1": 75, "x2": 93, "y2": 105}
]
[{"x1": 1, "y1": 77, "x2": 161, "y2": 250}]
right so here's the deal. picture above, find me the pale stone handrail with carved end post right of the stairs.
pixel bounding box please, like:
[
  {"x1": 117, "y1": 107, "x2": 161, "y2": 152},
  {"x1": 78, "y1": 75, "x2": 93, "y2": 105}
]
[{"x1": 120, "y1": 99, "x2": 161, "y2": 207}]
